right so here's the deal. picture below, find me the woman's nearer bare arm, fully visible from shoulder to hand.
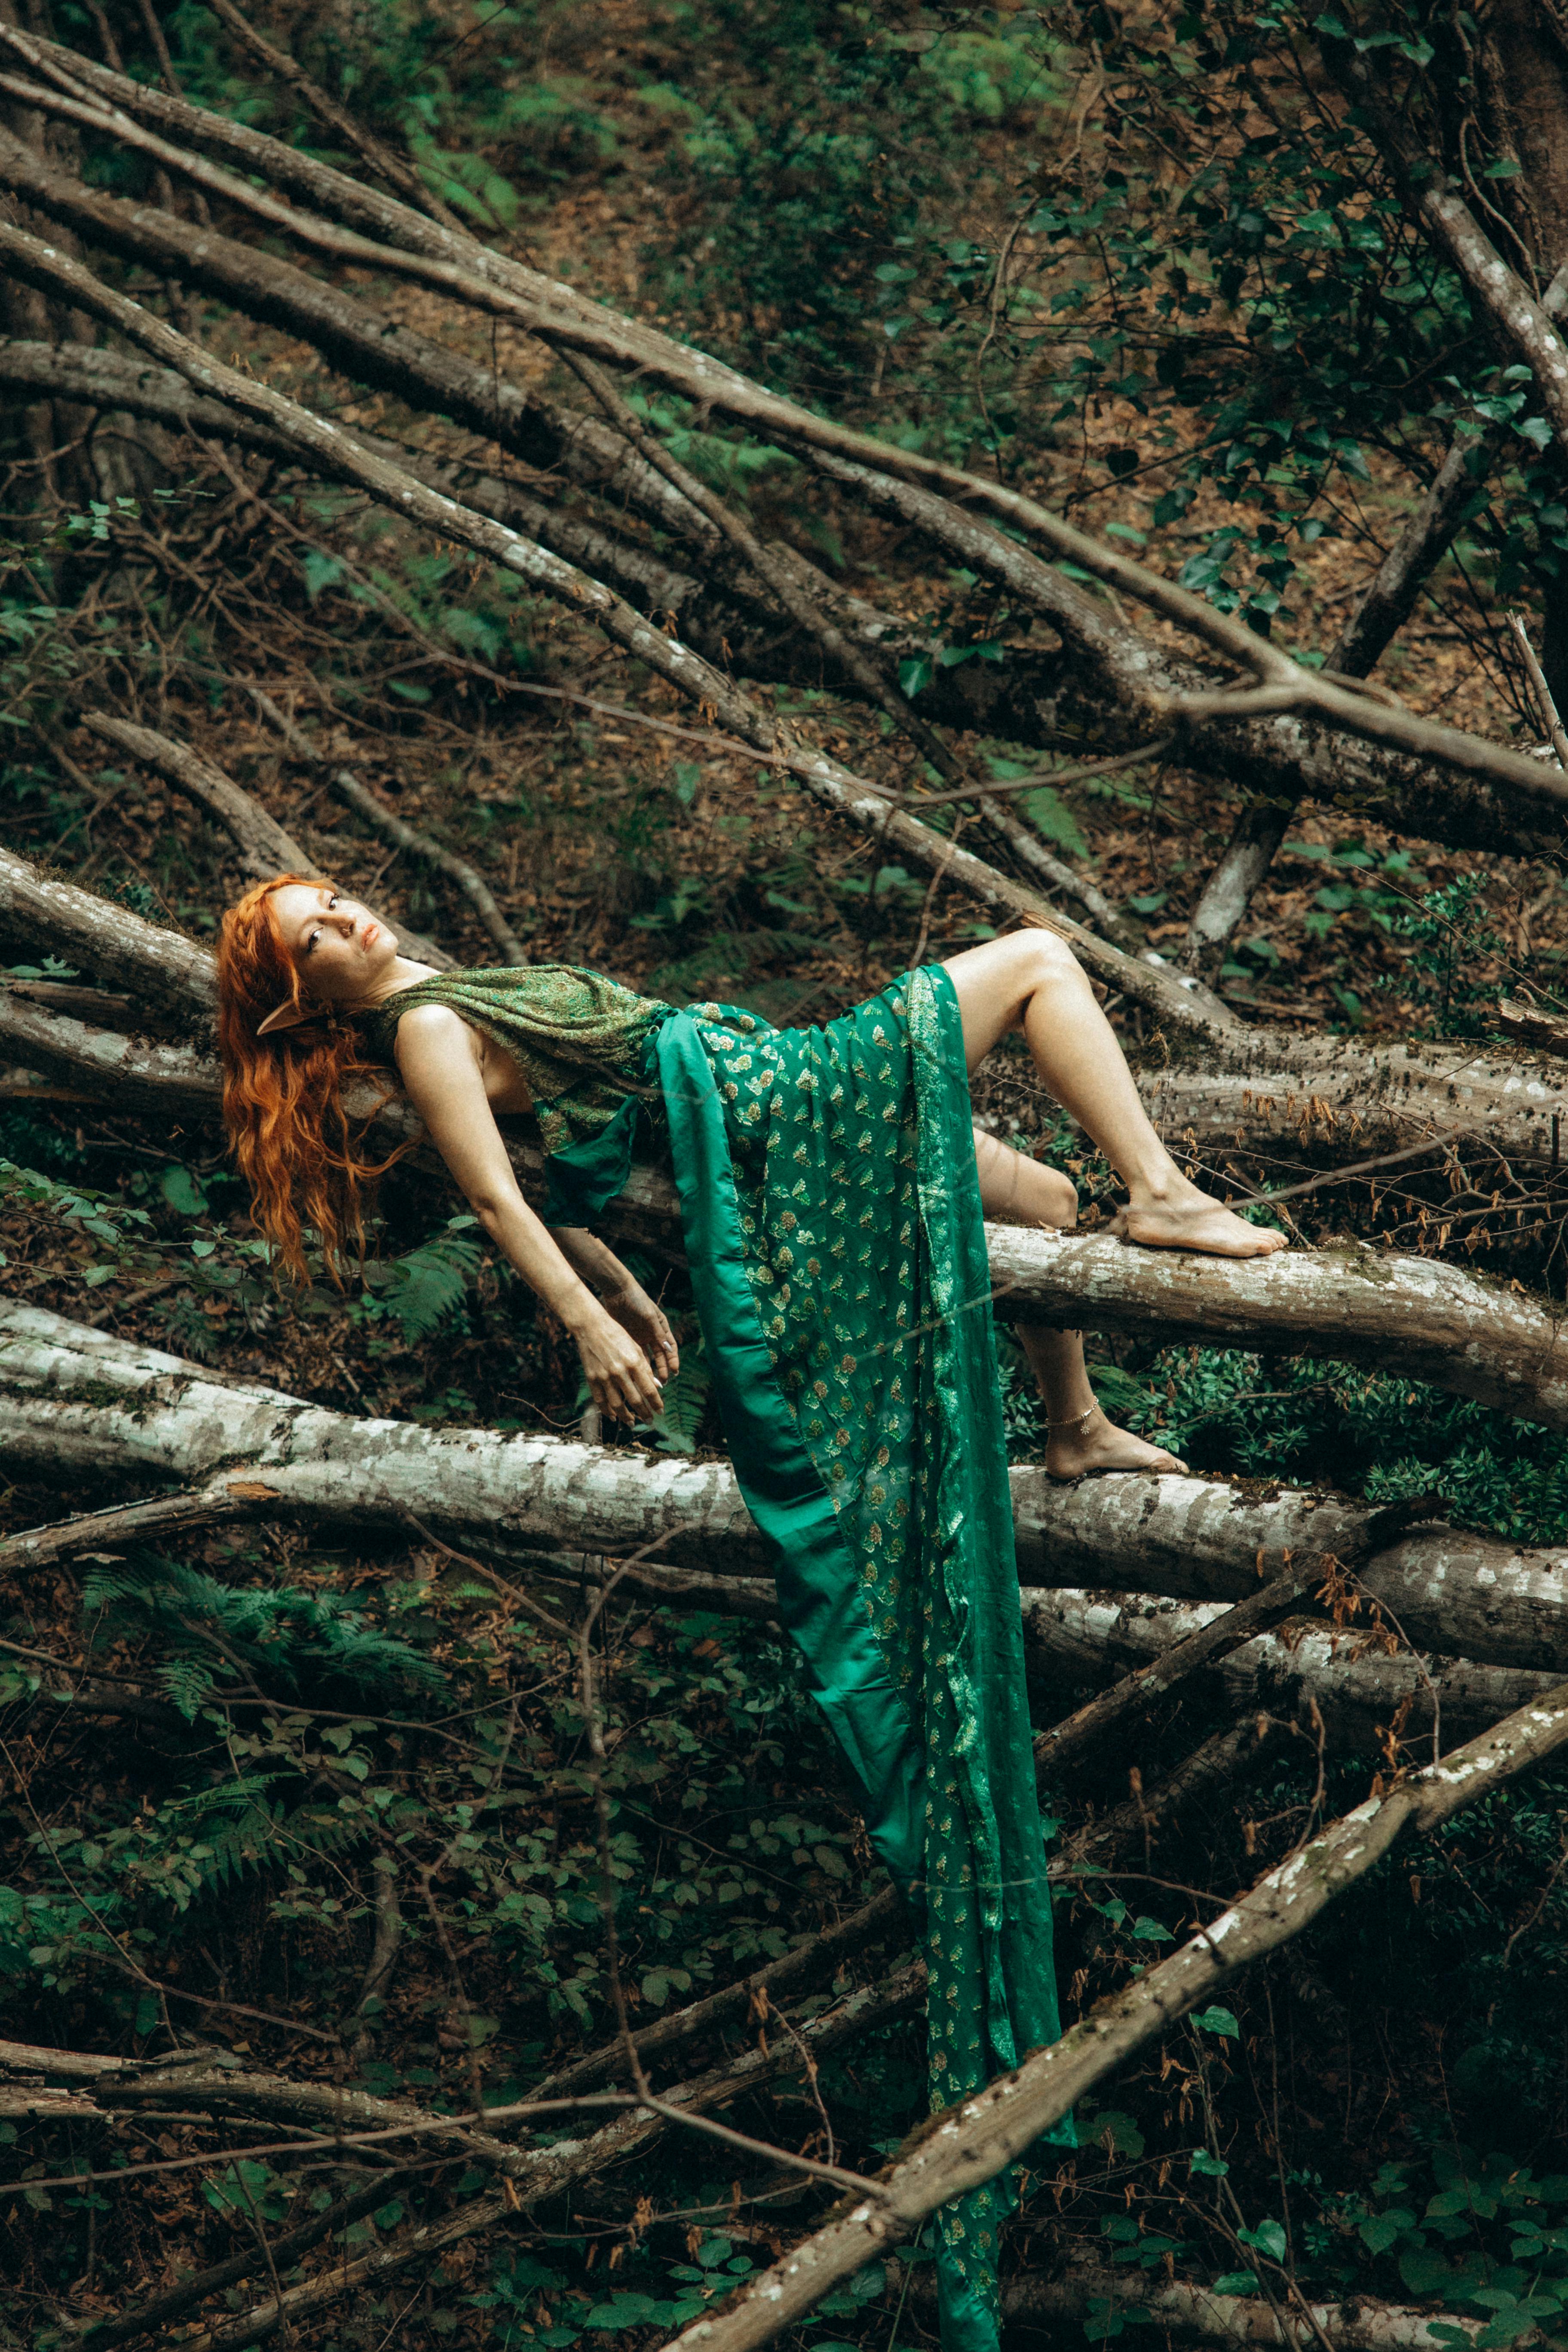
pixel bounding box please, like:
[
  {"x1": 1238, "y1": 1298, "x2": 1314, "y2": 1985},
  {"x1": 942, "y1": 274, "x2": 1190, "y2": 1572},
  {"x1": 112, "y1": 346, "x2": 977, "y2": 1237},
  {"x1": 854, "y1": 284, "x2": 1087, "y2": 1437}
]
[{"x1": 397, "y1": 1004, "x2": 663, "y2": 1421}]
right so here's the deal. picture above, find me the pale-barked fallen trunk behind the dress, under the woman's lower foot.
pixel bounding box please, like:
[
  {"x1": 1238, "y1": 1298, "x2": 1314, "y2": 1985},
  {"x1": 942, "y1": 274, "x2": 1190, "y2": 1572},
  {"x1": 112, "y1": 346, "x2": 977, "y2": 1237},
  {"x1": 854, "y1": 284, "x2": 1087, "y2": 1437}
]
[{"x1": 0, "y1": 1303, "x2": 1568, "y2": 1715}]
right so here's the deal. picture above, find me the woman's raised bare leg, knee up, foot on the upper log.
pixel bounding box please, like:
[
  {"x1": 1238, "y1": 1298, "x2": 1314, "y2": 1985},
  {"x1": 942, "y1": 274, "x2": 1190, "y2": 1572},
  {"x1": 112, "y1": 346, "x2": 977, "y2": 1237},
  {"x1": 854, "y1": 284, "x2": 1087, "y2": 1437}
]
[{"x1": 947, "y1": 931, "x2": 1286, "y2": 1259}]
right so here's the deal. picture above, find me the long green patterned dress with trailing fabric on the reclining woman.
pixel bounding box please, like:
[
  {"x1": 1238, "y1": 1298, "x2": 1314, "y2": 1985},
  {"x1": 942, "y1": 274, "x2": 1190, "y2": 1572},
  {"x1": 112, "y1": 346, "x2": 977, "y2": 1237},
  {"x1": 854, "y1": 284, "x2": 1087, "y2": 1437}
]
[{"x1": 362, "y1": 965, "x2": 1070, "y2": 2352}]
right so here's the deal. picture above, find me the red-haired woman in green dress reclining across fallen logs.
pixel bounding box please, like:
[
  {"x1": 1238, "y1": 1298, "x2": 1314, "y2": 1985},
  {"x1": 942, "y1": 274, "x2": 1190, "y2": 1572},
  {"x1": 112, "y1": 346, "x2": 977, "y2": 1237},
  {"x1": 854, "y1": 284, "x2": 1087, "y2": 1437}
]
[{"x1": 219, "y1": 875, "x2": 1283, "y2": 2352}]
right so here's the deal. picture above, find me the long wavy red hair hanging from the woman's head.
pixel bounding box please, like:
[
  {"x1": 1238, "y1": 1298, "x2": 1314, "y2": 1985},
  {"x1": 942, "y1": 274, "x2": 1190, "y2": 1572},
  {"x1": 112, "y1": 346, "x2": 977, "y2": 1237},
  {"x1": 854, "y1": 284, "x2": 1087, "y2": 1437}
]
[{"x1": 219, "y1": 875, "x2": 409, "y2": 1282}]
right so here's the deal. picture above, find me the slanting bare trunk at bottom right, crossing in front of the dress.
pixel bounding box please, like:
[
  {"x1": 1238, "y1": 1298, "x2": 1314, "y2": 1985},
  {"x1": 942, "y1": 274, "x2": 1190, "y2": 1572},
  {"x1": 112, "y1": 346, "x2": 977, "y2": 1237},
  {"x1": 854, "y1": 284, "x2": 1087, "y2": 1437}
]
[{"x1": 675, "y1": 1684, "x2": 1568, "y2": 2352}]
